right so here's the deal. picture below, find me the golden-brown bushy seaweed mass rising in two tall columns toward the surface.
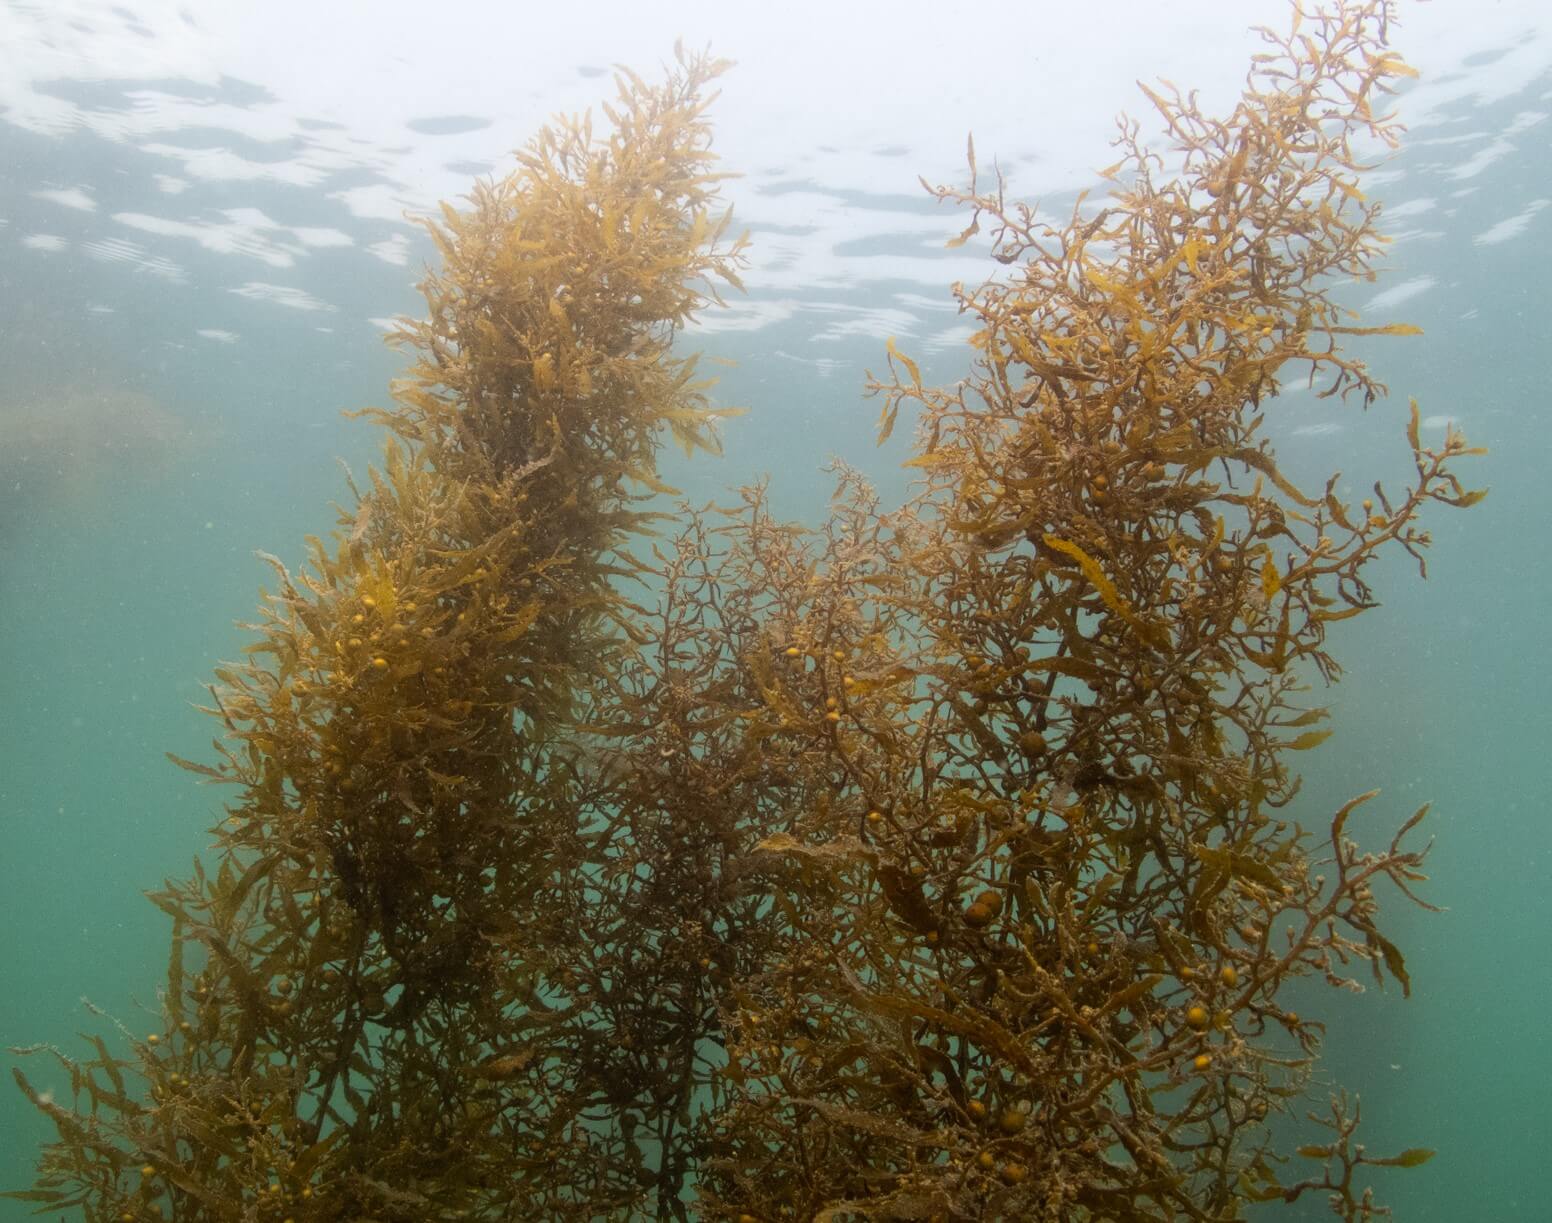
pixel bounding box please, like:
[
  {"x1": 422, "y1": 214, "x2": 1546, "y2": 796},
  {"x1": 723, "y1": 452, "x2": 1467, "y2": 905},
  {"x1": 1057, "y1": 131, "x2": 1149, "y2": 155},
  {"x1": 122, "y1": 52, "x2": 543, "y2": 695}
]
[{"x1": 6, "y1": 0, "x2": 1481, "y2": 1223}]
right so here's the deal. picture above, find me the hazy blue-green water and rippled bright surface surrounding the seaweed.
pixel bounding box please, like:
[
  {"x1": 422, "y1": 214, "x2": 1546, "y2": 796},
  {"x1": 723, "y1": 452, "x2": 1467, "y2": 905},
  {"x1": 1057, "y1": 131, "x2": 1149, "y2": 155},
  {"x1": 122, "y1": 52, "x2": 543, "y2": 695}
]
[{"x1": 0, "y1": 0, "x2": 1552, "y2": 1220}]
